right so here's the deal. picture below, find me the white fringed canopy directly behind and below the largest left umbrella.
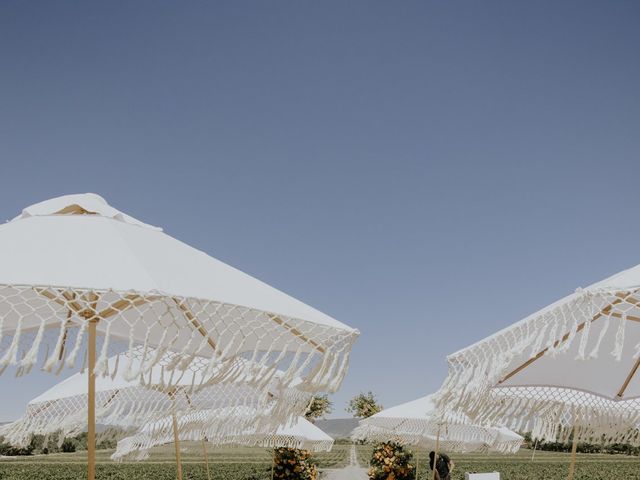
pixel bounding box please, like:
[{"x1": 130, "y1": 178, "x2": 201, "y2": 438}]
[{"x1": 0, "y1": 350, "x2": 310, "y2": 446}]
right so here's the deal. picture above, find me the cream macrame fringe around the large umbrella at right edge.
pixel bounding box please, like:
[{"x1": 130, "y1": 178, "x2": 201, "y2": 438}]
[{"x1": 436, "y1": 289, "x2": 640, "y2": 448}]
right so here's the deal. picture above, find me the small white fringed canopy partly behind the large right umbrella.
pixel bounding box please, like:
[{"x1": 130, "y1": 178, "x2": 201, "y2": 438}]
[{"x1": 353, "y1": 395, "x2": 523, "y2": 453}]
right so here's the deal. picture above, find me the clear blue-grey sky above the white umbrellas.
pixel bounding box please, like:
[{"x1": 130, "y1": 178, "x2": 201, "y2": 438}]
[{"x1": 0, "y1": 0, "x2": 640, "y2": 420}]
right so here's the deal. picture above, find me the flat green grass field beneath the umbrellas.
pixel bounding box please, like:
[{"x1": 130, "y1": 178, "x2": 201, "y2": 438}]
[{"x1": 0, "y1": 443, "x2": 640, "y2": 480}]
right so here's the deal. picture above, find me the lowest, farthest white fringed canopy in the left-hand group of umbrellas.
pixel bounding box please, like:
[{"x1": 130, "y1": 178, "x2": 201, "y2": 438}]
[{"x1": 111, "y1": 409, "x2": 333, "y2": 460}]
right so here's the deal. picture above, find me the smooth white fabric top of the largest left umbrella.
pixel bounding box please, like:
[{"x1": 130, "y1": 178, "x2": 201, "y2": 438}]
[{"x1": 0, "y1": 194, "x2": 352, "y2": 330}]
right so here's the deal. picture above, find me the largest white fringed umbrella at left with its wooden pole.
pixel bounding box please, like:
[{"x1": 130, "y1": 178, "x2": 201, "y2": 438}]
[{"x1": 0, "y1": 194, "x2": 358, "y2": 480}]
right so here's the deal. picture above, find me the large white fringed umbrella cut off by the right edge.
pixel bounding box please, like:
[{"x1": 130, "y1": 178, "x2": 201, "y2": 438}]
[{"x1": 438, "y1": 266, "x2": 640, "y2": 478}]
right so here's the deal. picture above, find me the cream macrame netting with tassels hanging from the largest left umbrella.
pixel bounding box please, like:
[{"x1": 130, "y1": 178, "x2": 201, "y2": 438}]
[{"x1": 0, "y1": 285, "x2": 357, "y2": 391}]
